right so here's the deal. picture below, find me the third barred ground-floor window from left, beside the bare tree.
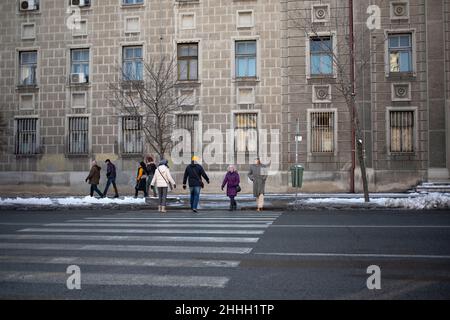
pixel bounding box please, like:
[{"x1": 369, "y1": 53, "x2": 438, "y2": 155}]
[{"x1": 122, "y1": 116, "x2": 143, "y2": 154}]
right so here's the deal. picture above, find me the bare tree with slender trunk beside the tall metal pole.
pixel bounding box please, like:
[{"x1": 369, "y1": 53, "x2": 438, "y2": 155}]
[{"x1": 289, "y1": 0, "x2": 372, "y2": 202}]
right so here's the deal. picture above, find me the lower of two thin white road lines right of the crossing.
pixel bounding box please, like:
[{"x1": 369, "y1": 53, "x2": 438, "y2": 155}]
[{"x1": 255, "y1": 252, "x2": 450, "y2": 259}]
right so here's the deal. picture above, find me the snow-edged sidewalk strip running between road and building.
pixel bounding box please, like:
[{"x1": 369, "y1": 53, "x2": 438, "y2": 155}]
[{"x1": 0, "y1": 193, "x2": 450, "y2": 212}]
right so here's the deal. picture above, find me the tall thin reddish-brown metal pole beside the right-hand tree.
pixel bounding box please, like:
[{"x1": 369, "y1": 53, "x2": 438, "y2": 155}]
[{"x1": 348, "y1": 0, "x2": 356, "y2": 193}]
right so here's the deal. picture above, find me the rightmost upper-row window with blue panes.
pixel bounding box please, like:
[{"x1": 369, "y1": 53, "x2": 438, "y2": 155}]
[{"x1": 388, "y1": 33, "x2": 413, "y2": 73}]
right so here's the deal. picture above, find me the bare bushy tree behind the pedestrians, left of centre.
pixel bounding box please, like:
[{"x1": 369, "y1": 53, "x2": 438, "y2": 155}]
[{"x1": 109, "y1": 56, "x2": 183, "y2": 159}]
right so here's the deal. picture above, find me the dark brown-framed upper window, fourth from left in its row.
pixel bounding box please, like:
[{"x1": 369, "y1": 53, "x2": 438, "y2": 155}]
[{"x1": 178, "y1": 43, "x2": 198, "y2": 81}]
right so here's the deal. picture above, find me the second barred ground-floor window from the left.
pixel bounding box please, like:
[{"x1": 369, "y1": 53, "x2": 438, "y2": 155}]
[{"x1": 68, "y1": 117, "x2": 89, "y2": 154}]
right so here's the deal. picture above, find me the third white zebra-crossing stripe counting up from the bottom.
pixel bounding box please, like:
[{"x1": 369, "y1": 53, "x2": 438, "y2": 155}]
[{"x1": 0, "y1": 242, "x2": 252, "y2": 254}]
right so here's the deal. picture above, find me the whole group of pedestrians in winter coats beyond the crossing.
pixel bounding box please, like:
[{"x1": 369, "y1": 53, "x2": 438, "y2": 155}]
[{"x1": 86, "y1": 156, "x2": 268, "y2": 213}]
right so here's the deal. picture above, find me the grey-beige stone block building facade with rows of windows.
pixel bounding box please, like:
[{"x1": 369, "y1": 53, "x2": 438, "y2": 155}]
[{"x1": 0, "y1": 0, "x2": 450, "y2": 193}]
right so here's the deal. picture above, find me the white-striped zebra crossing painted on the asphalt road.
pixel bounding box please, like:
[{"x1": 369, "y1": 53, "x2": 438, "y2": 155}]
[{"x1": 0, "y1": 212, "x2": 280, "y2": 294}]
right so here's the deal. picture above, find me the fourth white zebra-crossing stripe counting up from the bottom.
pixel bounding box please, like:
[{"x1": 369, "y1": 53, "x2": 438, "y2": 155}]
[{"x1": 0, "y1": 234, "x2": 259, "y2": 243}]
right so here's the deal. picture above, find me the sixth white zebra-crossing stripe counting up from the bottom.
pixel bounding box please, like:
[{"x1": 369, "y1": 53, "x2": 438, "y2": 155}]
[{"x1": 43, "y1": 223, "x2": 269, "y2": 228}]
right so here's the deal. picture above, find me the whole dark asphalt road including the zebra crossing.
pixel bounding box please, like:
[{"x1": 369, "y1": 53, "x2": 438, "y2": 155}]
[{"x1": 0, "y1": 210, "x2": 450, "y2": 300}]
